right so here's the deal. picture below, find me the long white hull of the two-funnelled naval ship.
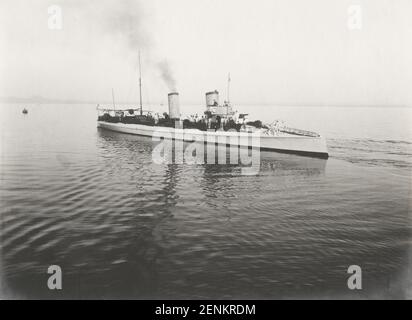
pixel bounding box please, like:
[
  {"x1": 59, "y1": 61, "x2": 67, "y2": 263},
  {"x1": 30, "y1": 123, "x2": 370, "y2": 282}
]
[{"x1": 98, "y1": 121, "x2": 329, "y2": 159}]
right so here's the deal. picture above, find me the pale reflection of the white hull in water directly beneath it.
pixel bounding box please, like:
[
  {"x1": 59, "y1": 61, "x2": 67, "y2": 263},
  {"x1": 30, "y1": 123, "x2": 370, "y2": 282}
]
[{"x1": 99, "y1": 129, "x2": 328, "y2": 178}]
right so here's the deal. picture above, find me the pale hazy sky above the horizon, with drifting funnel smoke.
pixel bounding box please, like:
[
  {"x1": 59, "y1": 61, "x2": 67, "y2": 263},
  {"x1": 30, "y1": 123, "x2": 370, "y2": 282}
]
[{"x1": 0, "y1": 0, "x2": 412, "y2": 106}]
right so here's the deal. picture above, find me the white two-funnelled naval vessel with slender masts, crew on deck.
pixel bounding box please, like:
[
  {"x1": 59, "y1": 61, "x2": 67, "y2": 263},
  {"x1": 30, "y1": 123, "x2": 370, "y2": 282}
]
[{"x1": 97, "y1": 59, "x2": 329, "y2": 159}]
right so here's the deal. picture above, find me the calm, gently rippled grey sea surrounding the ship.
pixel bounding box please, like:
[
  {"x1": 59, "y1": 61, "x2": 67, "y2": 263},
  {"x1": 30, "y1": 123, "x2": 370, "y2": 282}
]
[{"x1": 0, "y1": 105, "x2": 412, "y2": 299}]
